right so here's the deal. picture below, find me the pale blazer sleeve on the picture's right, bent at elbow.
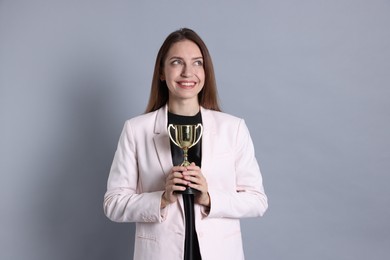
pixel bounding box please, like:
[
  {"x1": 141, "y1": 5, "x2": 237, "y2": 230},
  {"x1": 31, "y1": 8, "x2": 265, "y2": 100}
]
[{"x1": 207, "y1": 119, "x2": 268, "y2": 218}]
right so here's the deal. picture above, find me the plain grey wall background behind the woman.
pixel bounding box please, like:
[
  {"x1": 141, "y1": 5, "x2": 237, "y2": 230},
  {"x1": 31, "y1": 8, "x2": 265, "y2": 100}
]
[{"x1": 0, "y1": 0, "x2": 390, "y2": 260}]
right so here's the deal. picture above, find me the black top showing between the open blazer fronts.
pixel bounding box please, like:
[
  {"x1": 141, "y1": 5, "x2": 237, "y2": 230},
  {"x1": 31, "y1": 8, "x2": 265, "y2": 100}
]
[{"x1": 168, "y1": 112, "x2": 202, "y2": 260}]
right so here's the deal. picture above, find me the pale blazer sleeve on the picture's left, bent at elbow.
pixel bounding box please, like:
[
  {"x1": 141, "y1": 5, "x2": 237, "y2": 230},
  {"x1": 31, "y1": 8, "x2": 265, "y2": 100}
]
[{"x1": 103, "y1": 121, "x2": 165, "y2": 222}]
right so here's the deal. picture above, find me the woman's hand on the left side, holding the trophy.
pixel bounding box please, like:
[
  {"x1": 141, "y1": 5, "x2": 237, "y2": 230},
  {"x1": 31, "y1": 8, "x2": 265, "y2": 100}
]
[{"x1": 161, "y1": 166, "x2": 189, "y2": 208}]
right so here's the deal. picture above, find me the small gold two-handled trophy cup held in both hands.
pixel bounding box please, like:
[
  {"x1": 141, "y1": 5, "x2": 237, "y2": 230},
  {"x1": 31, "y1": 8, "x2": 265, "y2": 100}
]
[{"x1": 168, "y1": 124, "x2": 203, "y2": 194}]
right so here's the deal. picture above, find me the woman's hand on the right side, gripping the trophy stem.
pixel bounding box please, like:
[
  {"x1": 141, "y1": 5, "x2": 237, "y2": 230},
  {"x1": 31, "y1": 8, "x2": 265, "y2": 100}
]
[{"x1": 183, "y1": 163, "x2": 210, "y2": 207}]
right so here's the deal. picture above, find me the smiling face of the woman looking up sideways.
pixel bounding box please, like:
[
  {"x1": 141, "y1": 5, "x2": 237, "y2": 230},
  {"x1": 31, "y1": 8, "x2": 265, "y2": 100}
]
[{"x1": 161, "y1": 40, "x2": 205, "y2": 102}]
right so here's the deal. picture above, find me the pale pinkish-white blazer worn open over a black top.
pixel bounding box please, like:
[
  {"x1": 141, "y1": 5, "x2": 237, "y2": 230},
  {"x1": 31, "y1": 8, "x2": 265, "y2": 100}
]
[{"x1": 104, "y1": 106, "x2": 268, "y2": 260}]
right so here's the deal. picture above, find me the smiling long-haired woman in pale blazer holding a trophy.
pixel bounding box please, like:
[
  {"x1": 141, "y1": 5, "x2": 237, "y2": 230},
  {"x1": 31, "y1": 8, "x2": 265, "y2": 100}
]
[{"x1": 104, "y1": 28, "x2": 268, "y2": 260}]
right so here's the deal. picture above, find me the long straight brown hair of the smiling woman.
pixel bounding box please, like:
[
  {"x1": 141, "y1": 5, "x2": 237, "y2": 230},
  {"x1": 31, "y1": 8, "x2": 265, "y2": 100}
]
[{"x1": 145, "y1": 28, "x2": 221, "y2": 113}]
